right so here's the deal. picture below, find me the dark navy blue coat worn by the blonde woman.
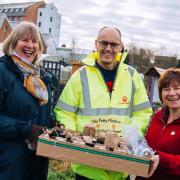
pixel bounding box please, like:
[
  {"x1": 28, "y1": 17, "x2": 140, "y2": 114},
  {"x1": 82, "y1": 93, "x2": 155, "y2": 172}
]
[{"x1": 0, "y1": 55, "x2": 54, "y2": 180}]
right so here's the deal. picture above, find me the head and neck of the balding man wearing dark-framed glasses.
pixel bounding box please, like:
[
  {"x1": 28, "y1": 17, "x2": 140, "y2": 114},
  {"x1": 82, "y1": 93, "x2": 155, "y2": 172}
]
[{"x1": 95, "y1": 28, "x2": 121, "y2": 69}]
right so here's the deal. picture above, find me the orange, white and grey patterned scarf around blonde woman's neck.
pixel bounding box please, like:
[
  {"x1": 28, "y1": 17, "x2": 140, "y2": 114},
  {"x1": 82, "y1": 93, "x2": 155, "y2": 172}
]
[{"x1": 11, "y1": 52, "x2": 48, "y2": 105}]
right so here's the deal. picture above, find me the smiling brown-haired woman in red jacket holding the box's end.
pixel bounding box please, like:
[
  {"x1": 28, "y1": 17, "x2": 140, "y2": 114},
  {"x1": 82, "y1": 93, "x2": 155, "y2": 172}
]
[{"x1": 136, "y1": 68, "x2": 180, "y2": 180}]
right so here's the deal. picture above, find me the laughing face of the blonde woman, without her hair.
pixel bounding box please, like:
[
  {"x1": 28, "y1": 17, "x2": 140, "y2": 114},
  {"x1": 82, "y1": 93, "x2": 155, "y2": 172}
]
[{"x1": 14, "y1": 35, "x2": 39, "y2": 63}]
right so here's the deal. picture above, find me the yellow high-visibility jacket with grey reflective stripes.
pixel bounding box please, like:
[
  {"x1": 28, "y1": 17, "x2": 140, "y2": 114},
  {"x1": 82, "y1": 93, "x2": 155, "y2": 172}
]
[{"x1": 55, "y1": 53, "x2": 152, "y2": 180}]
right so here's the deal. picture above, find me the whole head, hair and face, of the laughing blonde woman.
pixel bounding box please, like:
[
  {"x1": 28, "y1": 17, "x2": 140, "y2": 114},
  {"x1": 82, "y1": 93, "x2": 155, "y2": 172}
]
[{"x1": 3, "y1": 21, "x2": 43, "y2": 64}]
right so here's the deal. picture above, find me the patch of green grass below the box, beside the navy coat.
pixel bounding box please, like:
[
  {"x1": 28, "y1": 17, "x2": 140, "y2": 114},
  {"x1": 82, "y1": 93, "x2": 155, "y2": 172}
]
[{"x1": 48, "y1": 160, "x2": 75, "y2": 180}]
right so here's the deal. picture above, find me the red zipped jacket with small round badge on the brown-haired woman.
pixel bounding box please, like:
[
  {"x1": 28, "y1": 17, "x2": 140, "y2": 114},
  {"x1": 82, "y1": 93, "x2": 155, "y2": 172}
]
[{"x1": 137, "y1": 109, "x2": 180, "y2": 180}]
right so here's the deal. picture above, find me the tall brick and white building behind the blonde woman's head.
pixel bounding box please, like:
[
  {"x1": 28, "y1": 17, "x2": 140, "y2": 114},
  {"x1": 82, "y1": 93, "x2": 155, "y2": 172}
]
[{"x1": 0, "y1": 1, "x2": 61, "y2": 53}]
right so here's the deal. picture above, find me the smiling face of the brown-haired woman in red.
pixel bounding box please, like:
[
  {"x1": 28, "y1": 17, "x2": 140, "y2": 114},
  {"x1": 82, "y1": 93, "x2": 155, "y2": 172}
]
[{"x1": 162, "y1": 81, "x2": 180, "y2": 110}]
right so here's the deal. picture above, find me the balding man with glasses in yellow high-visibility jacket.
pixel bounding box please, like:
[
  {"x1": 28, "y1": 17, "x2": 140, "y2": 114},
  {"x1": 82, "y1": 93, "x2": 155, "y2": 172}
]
[{"x1": 55, "y1": 27, "x2": 152, "y2": 180}]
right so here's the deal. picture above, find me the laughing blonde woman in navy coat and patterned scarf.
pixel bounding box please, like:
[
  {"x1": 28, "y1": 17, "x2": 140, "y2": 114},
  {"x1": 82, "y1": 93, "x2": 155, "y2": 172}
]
[{"x1": 0, "y1": 22, "x2": 52, "y2": 180}]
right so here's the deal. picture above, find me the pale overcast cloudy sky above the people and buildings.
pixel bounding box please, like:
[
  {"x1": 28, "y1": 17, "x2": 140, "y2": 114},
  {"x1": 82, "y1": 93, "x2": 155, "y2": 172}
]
[{"x1": 0, "y1": 0, "x2": 180, "y2": 55}]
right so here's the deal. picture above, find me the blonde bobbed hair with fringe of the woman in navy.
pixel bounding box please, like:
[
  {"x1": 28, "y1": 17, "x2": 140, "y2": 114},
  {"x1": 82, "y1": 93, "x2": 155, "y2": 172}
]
[{"x1": 2, "y1": 21, "x2": 43, "y2": 63}]
